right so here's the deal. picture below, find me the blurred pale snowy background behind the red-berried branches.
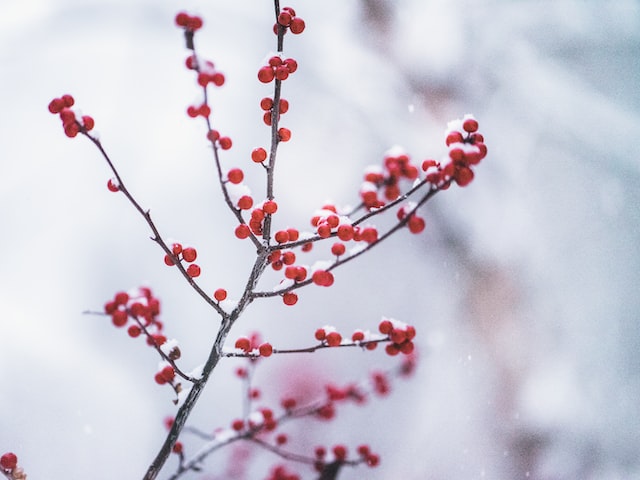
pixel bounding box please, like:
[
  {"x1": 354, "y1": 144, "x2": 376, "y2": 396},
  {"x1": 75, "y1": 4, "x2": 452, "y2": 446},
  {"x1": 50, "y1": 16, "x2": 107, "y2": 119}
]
[{"x1": 0, "y1": 0, "x2": 640, "y2": 480}]
